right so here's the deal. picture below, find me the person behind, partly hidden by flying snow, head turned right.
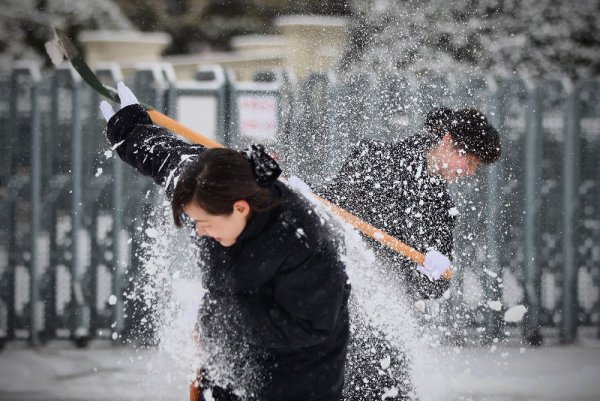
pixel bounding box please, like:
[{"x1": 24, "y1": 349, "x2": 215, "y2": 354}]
[{"x1": 316, "y1": 108, "x2": 501, "y2": 400}]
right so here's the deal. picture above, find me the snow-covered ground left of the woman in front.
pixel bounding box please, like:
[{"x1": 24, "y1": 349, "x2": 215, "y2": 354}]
[{"x1": 0, "y1": 342, "x2": 187, "y2": 401}]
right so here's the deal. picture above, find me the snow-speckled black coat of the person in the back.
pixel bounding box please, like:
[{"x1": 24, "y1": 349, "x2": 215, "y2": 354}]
[{"x1": 317, "y1": 135, "x2": 456, "y2": 298}]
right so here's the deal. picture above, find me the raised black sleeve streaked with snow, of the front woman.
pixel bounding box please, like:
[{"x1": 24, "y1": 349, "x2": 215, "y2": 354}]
[{"x1": 105, "y1": 104, "x2": 206, "y2": 194}]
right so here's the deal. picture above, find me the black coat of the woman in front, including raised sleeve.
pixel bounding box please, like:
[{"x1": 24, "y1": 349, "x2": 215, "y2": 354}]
[{"x1": 107, "y1": 106, "x2": 350, "y2": 401}]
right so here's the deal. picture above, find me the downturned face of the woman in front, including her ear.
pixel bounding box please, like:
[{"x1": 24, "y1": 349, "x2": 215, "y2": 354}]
[{"x1": 183, "y1": 200, "x2": 250, "y2": 247}]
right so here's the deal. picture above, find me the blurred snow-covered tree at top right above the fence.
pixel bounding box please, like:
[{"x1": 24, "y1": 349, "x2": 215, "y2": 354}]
[{"x1": 345, "y1": 0, "x2": 600, "y2": 78}]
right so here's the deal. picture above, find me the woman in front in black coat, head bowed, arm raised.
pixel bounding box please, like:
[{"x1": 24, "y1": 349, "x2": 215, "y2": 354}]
[{"x1": 101, "y1": 83, "x2": 350, "y2": 401}]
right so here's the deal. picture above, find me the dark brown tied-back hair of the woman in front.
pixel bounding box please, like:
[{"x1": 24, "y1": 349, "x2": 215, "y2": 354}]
[{"x1": 171, "y1": 148, "x2": 272, "y2": 227}]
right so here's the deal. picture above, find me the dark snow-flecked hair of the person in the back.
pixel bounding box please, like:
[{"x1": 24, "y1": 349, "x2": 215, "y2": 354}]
[{"x1": 425, "y1": 107, "x2": 501, "y2": 163}]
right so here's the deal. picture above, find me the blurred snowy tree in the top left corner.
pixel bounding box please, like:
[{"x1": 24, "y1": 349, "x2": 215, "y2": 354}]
[{"x1": 0, "y1": 0, "x2": 133, "y2": 73}]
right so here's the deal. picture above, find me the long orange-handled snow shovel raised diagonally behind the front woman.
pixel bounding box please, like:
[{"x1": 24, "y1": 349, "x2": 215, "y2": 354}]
[{"x1": 46, "y1": 28, "x2": 453, "y2": 280}]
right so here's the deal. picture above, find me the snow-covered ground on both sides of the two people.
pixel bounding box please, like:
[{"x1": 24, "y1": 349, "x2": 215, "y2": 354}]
[{"x1": 0, "y1": 340, "x2": 600, "y2": 401}]
